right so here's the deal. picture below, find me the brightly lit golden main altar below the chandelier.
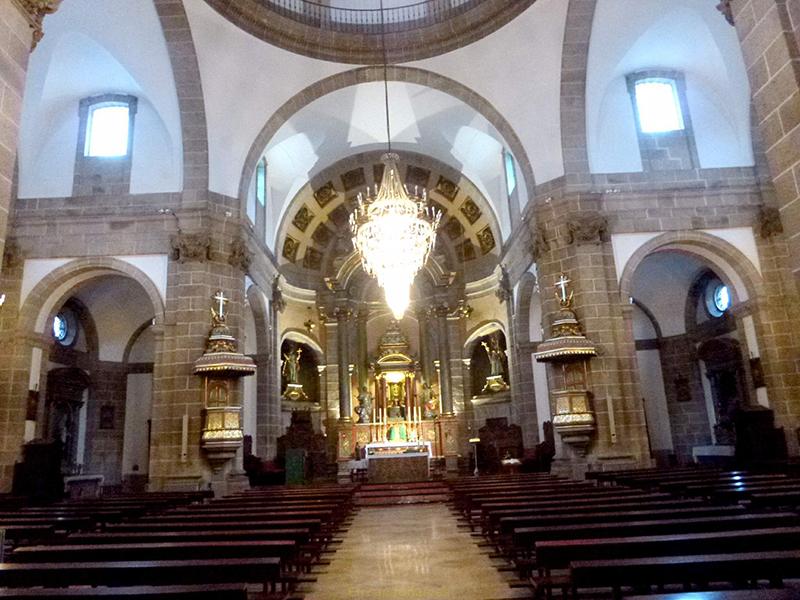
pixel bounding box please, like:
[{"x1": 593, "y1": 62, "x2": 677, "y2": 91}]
[{"x1": 338, "y1": 321, "x2": 455, "y2": 482}]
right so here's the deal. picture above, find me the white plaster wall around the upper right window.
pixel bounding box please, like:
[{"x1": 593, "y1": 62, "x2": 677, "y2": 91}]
[{"x1": 586, "y1": 0, "x2": 753, "y2": 173}]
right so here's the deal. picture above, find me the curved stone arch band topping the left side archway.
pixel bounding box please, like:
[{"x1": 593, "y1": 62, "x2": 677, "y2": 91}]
[{"x1": 19, "y1": 257, "x2": 164, "y2": 342}]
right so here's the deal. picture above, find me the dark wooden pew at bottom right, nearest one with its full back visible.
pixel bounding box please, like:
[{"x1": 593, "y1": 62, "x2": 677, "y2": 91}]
[{"x1": 570, "y1": 550, "x2": 800, "y2": 600}]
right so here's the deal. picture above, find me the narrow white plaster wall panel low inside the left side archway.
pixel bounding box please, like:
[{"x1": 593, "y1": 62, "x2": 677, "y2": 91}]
[{"x1": 122, "y1": 373, "x2": 153, "y2": 475}]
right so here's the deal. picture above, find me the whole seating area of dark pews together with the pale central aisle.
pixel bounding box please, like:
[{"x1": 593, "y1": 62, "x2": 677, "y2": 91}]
[{"x1": 0, "y1": 461, "x2": 800, "y2": 600}]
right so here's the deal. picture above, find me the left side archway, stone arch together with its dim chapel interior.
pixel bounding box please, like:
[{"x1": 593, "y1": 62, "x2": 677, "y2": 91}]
[{"x1": 21, "y1": 259, "x2": 163, "y2": 489}]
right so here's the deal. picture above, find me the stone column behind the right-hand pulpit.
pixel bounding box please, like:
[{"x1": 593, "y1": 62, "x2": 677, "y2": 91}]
[{"x1": 531, "y1": 199, "x2": 650, "y2": 477}]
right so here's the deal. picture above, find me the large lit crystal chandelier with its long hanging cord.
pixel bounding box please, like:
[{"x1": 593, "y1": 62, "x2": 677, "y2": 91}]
[{"x1": 350, "y1": 0, "x2": 441, "y2": 321}]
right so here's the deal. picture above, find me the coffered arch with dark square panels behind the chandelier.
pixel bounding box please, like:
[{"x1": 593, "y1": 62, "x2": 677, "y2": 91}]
[{"x1": 275, "y1": 152, "x2": 501, "y2": 287}]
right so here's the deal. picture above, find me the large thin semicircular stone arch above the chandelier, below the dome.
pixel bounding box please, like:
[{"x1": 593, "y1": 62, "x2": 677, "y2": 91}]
[{"x1": 239, "y1": 65, "x2": 536, "y2": 212}]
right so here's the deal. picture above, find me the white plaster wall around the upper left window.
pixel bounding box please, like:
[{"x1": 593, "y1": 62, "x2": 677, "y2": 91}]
[{"x1": 19, "y1": 0, "x2": 183, "y2": 198}]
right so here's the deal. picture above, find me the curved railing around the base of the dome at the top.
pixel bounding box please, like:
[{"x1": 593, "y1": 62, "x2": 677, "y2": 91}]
[{"x1": 259, "y1": 0, "x2": 486, "y2": 35}]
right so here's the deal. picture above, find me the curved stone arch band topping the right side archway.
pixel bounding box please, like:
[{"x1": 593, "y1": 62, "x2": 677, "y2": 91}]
[{"x1": 619, "y1": 231, "x2": 763, "y2": 306}]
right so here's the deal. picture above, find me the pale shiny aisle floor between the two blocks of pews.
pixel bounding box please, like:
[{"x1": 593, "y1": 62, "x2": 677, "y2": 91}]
[{"x1": 306, "y1": 504, "x2": 530, "y2": 600}]
